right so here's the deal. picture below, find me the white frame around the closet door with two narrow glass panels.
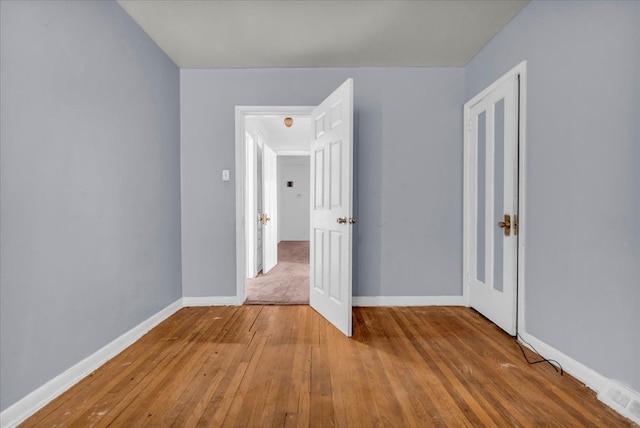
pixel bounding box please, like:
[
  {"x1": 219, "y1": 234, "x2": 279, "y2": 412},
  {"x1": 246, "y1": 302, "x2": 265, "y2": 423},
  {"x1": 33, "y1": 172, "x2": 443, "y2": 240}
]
[{"x1": 462, "y1": 60, "x2": 527, "y2": 334}]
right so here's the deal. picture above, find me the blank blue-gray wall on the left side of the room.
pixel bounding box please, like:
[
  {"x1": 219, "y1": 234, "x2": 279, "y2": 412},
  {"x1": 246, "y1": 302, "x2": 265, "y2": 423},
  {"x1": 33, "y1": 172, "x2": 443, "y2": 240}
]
[{"x1": 0, "y1": 1, "x2": 181, "y2": 410}]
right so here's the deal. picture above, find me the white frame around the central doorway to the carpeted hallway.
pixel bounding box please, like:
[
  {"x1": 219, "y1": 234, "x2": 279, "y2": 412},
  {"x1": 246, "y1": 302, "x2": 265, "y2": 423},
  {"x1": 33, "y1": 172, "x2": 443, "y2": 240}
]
[{"x1": 235, "y1": 106, "x2": 315, "y2": 305}]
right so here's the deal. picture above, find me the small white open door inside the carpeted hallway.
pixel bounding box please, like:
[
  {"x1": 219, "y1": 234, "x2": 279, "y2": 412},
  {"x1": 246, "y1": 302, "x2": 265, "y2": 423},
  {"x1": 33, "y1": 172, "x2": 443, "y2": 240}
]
[{"x1": 260, "y1": 144, "x2": 278, "y2": 274}]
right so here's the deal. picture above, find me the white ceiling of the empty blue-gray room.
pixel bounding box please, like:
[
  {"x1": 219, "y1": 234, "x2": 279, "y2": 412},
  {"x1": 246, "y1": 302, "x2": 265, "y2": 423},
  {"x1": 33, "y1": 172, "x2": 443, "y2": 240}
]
[{"x1": 118, "y1": 0, "x2": 528, "y2": 68}]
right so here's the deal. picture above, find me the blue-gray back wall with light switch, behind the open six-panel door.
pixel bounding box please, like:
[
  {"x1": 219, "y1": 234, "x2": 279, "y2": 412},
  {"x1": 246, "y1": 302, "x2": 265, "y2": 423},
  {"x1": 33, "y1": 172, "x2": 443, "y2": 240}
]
[{"x1": 180, "y1": 68, "x2": 464, "y2": 296}]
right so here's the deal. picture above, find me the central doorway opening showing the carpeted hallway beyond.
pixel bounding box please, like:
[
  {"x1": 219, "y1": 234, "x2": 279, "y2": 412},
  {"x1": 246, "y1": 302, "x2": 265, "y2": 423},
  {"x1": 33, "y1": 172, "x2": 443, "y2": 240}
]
[{"x1": 236, "y1": 106, "x2": 313, "y2": 304}]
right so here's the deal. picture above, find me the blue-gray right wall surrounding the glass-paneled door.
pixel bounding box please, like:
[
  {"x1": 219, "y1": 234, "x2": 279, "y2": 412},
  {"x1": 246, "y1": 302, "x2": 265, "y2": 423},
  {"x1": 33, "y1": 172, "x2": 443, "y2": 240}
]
[{"x1": 466, "y1": 1, "x2": 640, "y2": 391}]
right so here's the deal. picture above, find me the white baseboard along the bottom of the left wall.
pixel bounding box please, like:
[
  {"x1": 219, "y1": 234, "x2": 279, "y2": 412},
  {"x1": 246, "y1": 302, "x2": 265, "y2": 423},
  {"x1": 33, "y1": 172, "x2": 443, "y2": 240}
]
[{"x1": 0, "y1": 299, "x2": 182, "y2": 428}]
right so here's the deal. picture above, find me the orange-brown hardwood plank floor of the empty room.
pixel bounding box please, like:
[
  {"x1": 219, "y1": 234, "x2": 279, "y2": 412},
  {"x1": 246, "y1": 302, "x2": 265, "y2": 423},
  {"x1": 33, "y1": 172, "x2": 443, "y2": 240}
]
[{"x1": 22, "y1": 306, "x2": 633, "y2": 427}]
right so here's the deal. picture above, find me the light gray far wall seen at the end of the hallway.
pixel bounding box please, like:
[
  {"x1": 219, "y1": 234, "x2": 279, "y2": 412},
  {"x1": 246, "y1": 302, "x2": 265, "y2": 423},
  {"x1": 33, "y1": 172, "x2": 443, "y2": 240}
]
[{"x1": 278, "y1": 156, "x2": 311, "y2": 241}]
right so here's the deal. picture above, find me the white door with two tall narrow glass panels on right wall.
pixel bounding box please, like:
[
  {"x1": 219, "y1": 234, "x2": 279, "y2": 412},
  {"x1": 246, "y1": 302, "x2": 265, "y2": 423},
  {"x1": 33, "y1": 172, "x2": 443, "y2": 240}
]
[{"x1": 464, "y1": 74, "x2": 519, "y2": 336}]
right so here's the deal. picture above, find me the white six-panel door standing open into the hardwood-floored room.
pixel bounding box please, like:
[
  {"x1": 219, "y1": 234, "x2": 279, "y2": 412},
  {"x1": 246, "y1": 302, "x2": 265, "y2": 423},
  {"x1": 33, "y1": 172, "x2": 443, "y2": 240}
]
[{"x1": 309, "y1": 79, "x2": 355, "y2": 336}]
